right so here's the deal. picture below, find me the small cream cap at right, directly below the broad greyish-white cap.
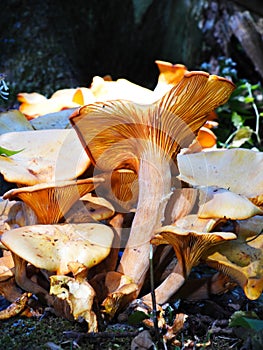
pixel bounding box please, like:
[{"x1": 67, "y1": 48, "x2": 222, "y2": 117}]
[{"x1": 198, "y1": 186, "x2": 263, "y2": 220}]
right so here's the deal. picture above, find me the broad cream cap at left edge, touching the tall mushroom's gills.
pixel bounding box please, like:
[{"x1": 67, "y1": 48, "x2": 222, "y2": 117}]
[{"x1": 0, "y1": 129, "x2": 90, "y2": 185}]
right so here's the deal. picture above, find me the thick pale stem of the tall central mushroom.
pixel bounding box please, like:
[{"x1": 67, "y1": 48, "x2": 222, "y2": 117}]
[{"x1": 118, "y1": 145, "x2": 171, "y2": 293}]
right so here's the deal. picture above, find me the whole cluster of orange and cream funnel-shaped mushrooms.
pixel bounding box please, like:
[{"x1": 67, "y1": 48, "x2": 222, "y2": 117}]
[{"x1": 0, "y1": 61, "x2": 263, "y2": 332}]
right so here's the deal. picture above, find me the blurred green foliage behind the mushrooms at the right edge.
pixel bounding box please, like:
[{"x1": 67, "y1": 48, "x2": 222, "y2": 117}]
[{"x1": 201, "y1": 56, "x2": 263, "y2": 151}]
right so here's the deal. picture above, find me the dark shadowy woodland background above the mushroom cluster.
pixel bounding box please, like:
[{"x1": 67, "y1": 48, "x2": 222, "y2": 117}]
[{"x1": 0, "y1": 0, "x2": 263, "y2": 103}]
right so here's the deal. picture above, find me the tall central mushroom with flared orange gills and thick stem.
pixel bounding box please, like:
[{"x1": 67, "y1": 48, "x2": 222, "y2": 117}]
[{"x1": 70, "y1": 72, "x2": 235, "y2": 292}]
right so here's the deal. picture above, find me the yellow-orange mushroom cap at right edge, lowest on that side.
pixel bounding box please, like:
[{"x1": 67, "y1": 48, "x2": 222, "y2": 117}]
[{"x1": 206, "y1": 235, "x2": 263, "y2": 300}]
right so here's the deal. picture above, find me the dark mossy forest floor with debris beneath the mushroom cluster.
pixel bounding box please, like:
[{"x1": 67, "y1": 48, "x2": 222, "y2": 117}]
[{"x1": 0, "y1": 278, "x2": 263, "y2": 350}]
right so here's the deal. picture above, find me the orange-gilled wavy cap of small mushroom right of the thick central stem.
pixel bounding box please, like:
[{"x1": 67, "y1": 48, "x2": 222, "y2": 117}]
[{"x1": 151, "y1": 226, "x2": 236, "y2": 277}]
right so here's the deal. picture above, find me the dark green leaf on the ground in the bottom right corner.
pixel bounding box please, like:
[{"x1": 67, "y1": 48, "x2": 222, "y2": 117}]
[{"x1": 229, "y1": 311, "x2": 263, "y2": 332}]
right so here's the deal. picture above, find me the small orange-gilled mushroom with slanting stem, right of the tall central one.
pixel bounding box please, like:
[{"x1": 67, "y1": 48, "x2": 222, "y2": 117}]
[{"x1": 142, "y1": 225, "x2": 236, "y2": 304}]
